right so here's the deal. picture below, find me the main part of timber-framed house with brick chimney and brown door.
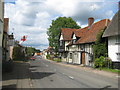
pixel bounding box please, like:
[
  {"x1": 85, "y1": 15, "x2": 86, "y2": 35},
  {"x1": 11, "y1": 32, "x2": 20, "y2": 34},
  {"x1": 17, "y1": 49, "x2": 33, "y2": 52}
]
[{"x1": 60, "y1": 17, "x2": 110, "y2": 66}]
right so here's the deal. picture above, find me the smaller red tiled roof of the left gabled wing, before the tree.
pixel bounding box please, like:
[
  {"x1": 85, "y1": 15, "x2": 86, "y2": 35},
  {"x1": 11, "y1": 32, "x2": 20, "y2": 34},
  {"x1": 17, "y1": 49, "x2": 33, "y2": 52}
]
[{"x1": 61, "y1": 28, "x2": 78, "y2": 40}]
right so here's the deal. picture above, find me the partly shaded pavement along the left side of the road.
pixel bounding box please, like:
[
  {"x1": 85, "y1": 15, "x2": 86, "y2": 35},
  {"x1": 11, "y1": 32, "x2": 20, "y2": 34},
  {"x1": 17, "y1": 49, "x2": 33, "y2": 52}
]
[{"x1": 2, "y1": 62, "x2": 30, "y2": 89}]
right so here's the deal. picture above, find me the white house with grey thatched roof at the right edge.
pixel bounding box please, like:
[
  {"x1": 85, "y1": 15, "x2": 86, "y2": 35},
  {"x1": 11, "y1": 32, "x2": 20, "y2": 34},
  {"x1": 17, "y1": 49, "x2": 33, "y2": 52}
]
[{"x1": 103, "y1": 10, "x2": 120, "y2": 68}]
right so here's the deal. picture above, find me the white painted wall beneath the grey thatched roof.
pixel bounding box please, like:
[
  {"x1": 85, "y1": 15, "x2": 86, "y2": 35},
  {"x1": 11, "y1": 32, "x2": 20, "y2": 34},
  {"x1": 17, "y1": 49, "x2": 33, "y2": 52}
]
[{"x1": 108, "y1": 36, "x2": 120, "y2": 62}]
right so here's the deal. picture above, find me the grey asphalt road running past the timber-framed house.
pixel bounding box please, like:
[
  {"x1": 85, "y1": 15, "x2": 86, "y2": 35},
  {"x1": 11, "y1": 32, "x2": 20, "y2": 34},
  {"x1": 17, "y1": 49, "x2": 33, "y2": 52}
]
[{"x1": 29, "y1": 57, "x2": 118, "y2": 88}]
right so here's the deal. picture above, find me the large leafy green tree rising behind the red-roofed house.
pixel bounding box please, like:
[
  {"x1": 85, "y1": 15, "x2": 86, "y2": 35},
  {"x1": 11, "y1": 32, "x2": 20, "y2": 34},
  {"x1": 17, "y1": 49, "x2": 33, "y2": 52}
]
[{"x1": 47, "y1": 17, "x2": 80, "y2": 51}]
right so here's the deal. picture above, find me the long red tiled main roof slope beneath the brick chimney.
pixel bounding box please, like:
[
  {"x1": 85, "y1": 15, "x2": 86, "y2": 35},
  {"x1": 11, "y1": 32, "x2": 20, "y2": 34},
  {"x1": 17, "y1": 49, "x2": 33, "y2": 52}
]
[{"x1": 75, "y1": 19, "x2": 110, "y2": 44}]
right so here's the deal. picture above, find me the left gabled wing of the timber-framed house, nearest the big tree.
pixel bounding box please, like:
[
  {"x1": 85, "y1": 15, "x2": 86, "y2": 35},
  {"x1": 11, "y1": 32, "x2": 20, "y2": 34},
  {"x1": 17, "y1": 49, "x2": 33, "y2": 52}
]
[{"x1": 58, "y1": 28, "x2": 77, "y2": 62}]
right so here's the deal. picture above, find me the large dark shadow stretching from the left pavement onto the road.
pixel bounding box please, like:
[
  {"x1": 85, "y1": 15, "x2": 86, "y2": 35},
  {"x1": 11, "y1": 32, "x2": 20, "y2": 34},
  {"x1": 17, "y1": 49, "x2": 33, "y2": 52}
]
[{"x1": 2, "y1": 63, "x2": 54, "y2": 81}]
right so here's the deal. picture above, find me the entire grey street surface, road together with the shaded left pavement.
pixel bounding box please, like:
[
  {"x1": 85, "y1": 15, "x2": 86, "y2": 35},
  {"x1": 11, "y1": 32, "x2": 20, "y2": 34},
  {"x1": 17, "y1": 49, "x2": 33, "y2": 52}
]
[{"x1": 3, "y1": 58, "x2": 119, "y2": 90}]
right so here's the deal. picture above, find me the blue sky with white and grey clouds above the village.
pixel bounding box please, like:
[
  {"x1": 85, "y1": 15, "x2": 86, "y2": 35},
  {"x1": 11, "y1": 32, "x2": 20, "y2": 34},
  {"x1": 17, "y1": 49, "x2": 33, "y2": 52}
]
[{"x1": 4, "y1": 0, "x2": 119, "y2": 50}]
